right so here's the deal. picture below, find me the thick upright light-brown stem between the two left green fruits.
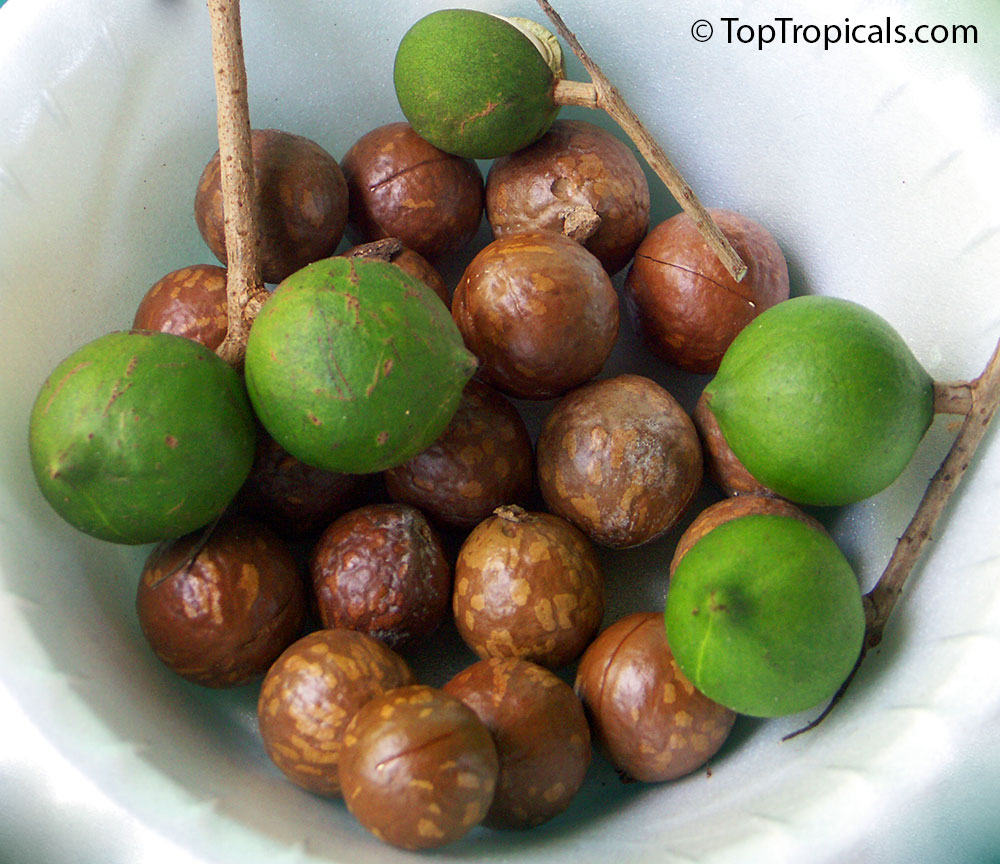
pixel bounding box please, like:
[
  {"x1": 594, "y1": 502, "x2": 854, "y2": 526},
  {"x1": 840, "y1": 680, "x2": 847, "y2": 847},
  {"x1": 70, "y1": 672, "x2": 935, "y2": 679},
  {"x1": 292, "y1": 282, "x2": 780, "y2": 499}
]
[{"x1": 208, "y1": 0, "x2": 267, "y2": 368}]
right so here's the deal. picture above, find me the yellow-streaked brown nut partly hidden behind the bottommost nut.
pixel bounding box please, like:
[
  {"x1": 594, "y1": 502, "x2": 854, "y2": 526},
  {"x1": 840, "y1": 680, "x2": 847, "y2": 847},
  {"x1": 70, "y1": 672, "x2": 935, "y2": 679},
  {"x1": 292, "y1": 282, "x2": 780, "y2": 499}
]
[{"x1": 257, "y1": 629, "x2": 414, "y2": 796}]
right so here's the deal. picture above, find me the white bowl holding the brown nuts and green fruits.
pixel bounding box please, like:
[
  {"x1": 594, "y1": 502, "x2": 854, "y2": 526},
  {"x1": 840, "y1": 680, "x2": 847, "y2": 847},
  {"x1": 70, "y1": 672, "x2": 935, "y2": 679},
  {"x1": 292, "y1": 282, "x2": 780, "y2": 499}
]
[{"x1": 0, "y1": 0, "x2": 1000, "y2": 864}]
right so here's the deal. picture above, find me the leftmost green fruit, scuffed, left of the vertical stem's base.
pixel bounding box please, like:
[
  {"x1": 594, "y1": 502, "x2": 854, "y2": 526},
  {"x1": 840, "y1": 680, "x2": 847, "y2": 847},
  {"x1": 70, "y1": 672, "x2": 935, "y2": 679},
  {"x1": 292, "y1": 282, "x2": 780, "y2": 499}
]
[{"x1": 28, "y1": 331, "x2": 256, "y2": 544}]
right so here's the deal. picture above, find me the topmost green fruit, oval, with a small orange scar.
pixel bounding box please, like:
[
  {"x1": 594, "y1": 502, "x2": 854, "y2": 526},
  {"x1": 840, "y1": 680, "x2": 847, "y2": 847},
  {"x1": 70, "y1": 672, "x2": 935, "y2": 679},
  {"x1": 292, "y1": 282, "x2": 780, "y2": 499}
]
[{"x1": 393, "y1": 9, "x2": 559, "y2": 159}]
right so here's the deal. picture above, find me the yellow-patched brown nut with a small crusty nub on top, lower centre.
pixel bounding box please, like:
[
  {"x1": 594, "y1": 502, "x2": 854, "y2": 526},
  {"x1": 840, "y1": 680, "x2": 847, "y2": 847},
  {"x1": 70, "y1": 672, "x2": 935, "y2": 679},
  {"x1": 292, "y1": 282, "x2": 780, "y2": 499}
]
[{"x1": 452, "y1": 506, "x2": 604, "y2": 669}]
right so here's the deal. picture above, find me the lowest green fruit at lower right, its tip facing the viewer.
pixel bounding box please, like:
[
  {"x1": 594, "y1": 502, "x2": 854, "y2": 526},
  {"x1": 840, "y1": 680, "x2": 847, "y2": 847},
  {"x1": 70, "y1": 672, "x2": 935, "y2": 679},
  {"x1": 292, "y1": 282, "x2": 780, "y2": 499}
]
[{"x1": 665, "y1": 515, "x2": 865, "y2": 717}]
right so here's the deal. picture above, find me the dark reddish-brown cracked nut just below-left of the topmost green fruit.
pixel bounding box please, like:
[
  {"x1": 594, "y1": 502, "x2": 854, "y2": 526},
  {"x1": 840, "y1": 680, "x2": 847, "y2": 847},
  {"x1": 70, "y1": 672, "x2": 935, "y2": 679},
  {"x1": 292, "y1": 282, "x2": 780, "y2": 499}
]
[{"x1": 342, "y1": 122, "x2": 483, "y2": 261}]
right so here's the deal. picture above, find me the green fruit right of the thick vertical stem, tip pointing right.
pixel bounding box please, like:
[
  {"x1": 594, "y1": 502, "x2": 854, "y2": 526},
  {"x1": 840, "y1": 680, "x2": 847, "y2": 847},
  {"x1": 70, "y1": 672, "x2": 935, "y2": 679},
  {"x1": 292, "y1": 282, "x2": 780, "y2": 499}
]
[{"x1": 245, "y1": 258, "x2": 477, "y2": 474}]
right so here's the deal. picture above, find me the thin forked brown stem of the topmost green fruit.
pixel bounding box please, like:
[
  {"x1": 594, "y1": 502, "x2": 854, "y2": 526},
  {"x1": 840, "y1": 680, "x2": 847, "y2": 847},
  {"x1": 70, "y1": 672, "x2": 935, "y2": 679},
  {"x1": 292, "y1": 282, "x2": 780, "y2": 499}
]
[{"x1": 538, "y1": 0, "x2": 747, "y2": 282}]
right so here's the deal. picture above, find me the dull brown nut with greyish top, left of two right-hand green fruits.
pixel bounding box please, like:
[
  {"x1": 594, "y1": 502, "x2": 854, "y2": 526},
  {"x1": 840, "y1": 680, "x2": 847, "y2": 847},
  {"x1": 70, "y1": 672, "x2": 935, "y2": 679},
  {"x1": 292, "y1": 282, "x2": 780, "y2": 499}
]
[{"x1": 538, "y1": 375, "x2": 702, "y2": 548}]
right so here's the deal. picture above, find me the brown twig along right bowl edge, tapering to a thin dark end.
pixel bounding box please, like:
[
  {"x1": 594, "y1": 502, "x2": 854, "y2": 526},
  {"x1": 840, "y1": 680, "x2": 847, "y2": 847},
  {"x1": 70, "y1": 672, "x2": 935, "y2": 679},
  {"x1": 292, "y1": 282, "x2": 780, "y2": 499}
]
[{"x1": 783, "y1": 334, "x2": 1000, "y2": 740}]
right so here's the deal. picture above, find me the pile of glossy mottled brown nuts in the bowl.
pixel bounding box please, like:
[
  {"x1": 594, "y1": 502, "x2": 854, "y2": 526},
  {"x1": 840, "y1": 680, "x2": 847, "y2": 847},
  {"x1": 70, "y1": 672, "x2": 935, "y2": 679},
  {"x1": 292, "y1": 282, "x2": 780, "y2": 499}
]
[{"x1": 125, "y1": 103, "x2": 788, "y2": 848}]
